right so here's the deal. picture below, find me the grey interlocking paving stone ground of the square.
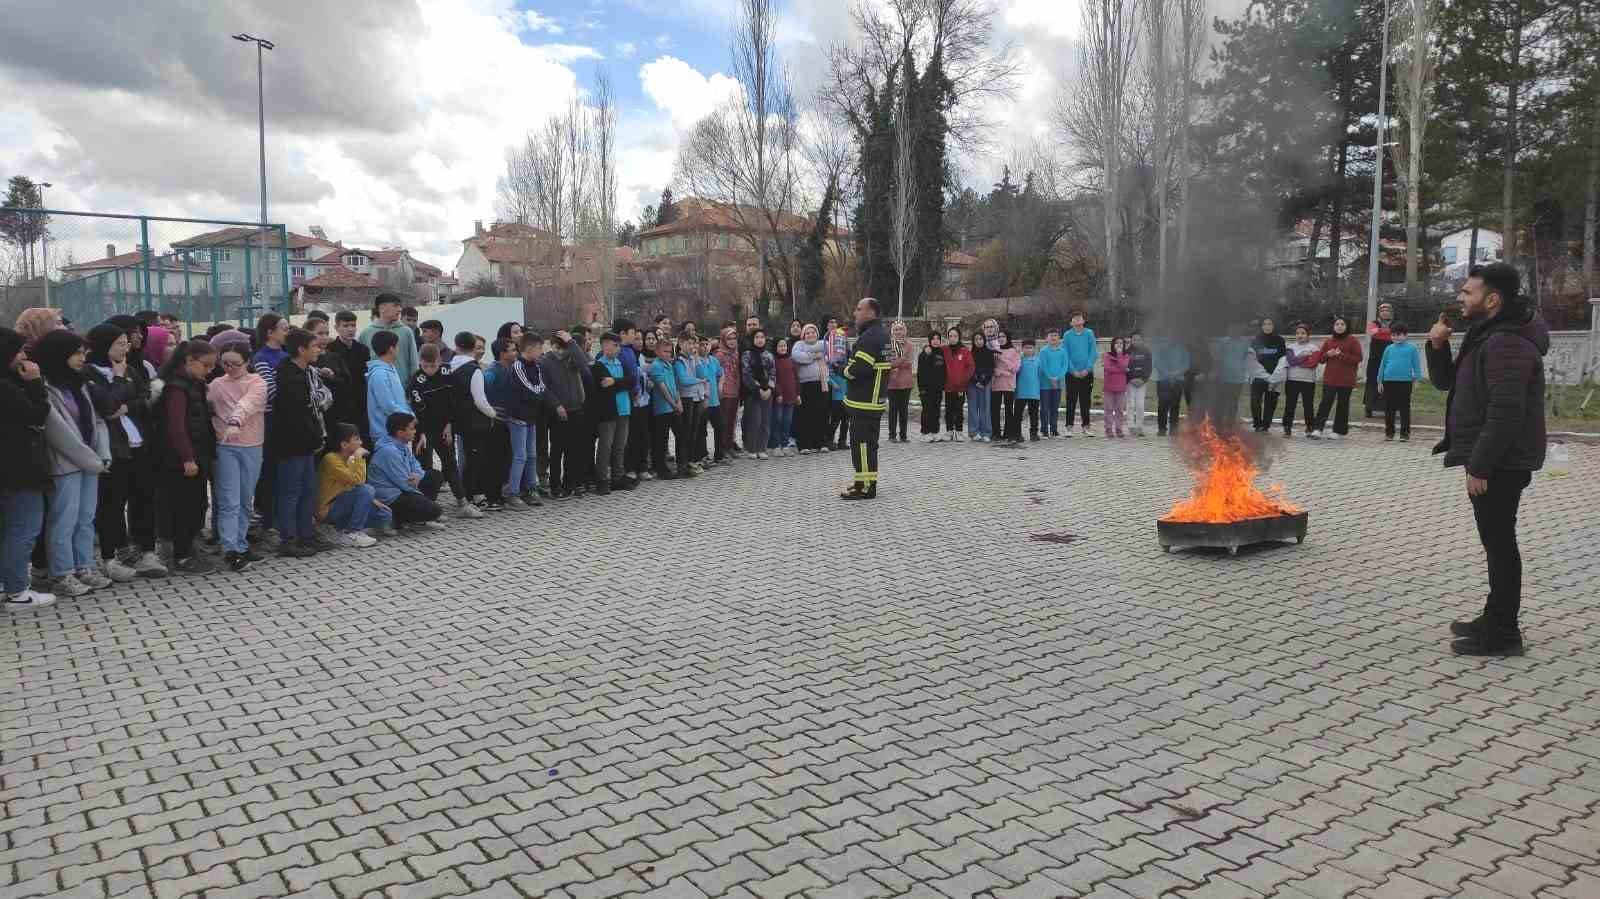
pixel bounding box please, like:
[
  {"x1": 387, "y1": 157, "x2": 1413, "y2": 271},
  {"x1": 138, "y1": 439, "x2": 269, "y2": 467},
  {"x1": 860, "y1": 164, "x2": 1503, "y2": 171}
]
[{"x1": 0, "y1": 422, "x2": 1600, "y2": 899}]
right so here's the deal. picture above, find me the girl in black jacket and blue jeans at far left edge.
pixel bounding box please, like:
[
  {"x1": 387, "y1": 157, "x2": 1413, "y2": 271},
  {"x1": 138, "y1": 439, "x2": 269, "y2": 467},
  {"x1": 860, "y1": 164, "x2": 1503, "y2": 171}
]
[{"x1": 0, "y1": 328, "x2": 56, "y2": 611}]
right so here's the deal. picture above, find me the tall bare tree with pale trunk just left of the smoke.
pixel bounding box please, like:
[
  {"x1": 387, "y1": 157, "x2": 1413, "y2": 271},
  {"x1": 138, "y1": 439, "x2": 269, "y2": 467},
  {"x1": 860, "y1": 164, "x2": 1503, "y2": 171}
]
[{"x1": 1056, "y1": 0, "x2": 1139, "y2": 306}]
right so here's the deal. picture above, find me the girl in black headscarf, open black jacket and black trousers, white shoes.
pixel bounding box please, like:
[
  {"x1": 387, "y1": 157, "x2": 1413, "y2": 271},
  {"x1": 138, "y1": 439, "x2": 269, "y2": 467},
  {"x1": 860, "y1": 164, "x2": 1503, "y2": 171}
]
[{"x1": 83, "y1": 323, "x2": 166, "y2": 582}]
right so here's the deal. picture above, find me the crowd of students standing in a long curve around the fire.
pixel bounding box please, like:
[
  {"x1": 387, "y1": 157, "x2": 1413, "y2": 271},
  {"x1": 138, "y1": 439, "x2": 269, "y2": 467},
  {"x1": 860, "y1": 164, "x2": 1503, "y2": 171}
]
[{"x1": 0, "y1": 294, "x2": 1421, "y2": 608}]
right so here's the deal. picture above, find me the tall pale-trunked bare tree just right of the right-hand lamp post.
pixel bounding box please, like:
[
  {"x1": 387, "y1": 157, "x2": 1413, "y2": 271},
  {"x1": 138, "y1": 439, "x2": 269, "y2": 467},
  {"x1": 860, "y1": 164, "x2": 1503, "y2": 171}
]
[{"x1": 1394, "y1": 0, "x2": 1440, "y2": 299}]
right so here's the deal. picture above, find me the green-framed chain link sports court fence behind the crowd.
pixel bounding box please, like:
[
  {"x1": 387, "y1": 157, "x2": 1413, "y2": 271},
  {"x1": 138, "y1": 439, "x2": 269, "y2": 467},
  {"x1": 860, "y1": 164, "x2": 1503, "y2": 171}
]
[{"x1": 0, "y1": 208, "x2": 294, "y2": 333}]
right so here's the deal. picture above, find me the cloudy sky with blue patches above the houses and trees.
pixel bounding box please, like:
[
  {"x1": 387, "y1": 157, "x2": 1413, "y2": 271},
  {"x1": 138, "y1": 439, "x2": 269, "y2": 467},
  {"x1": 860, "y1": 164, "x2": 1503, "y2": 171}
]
[{"x1": 0, "y1": 0, "x2": 1164, "y2": 270}]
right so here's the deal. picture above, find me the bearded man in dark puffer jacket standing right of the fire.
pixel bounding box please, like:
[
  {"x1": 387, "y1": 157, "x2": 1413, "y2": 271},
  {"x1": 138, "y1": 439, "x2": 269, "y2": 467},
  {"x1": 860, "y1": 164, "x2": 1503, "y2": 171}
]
[{"x1": 1427, "y1": 262, "x2": 1550, "y2": 656}]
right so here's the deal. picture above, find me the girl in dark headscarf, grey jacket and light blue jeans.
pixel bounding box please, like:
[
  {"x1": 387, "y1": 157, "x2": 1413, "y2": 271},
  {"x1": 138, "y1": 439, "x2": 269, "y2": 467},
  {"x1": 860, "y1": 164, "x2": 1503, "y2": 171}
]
[{"x1": 29, "y1": 331, "x2": 110, "y2": 597}]
